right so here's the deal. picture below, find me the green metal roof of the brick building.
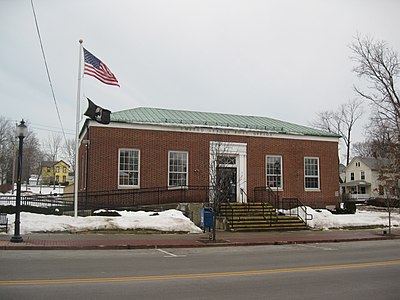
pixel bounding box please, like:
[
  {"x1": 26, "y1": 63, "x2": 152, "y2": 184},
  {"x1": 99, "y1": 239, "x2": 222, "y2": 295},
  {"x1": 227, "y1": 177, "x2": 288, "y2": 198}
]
[{"x1": 111, "y1": 107, "x2": 339, "y2": 137}]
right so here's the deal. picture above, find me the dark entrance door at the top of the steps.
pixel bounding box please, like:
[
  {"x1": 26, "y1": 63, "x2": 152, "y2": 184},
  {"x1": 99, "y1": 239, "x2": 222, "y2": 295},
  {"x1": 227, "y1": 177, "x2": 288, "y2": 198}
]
[{"x1": 216, "y1": 167, "x2": 237, "y2": 202}]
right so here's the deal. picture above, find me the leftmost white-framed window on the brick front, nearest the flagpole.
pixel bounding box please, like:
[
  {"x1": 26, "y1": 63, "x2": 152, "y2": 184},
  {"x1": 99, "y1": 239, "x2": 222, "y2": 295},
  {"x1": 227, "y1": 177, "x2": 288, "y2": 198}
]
[{"x1": 118, "y1": 149, "x2": 140, "y2": 188}]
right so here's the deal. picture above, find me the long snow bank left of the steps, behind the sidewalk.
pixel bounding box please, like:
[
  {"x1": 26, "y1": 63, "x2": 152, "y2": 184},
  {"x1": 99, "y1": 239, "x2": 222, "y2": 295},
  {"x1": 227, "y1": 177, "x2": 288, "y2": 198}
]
[{"x1": 1, "y1": 209, "x2": 202, "y2": 234}]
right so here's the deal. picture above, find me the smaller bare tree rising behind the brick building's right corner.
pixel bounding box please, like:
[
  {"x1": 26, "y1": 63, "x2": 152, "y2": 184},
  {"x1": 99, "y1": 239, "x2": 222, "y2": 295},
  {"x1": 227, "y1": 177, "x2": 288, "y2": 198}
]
[{"x1": 312, "y1": 99, "x2": 363, "y2": 165}]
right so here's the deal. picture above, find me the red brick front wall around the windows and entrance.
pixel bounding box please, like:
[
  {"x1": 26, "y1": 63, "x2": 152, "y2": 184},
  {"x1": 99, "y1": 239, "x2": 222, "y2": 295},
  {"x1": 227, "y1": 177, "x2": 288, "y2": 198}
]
[{"x1": 80, "y1": 127, "x2": 339, "y2": 207}]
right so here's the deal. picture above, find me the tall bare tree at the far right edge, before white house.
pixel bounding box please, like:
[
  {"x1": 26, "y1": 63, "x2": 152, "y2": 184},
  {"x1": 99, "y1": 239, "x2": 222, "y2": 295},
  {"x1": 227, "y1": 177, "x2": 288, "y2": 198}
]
[{"x1": 350, "y1": 35, "x2": 400, "y2": 178}]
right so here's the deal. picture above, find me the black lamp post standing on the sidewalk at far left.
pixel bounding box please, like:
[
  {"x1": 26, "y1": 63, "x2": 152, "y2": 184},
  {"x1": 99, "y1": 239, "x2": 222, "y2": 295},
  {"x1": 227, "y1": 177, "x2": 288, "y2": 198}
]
[{"x1": 10, "y1": 120, "x2": 27, "y2": 243}]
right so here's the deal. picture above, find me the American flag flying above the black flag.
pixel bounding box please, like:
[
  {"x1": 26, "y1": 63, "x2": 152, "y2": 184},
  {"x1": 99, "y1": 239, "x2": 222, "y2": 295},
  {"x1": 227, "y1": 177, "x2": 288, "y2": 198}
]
[{"x1": 83, "y1": 48, "x2": 119, "y2": 86}]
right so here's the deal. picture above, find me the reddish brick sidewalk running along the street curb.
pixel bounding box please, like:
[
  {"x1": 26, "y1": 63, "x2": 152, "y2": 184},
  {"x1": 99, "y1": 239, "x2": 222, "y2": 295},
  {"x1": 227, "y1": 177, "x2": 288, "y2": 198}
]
[{"x1": 0, "y1": 228, "x2": 400, "y2": 250}]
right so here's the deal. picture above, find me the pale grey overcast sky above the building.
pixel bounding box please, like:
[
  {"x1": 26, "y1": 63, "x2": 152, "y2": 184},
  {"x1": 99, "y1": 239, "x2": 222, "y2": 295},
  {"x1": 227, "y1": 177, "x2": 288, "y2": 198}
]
[{"x1": 0, "y1": 0, "x2": 400, "y2": 155}]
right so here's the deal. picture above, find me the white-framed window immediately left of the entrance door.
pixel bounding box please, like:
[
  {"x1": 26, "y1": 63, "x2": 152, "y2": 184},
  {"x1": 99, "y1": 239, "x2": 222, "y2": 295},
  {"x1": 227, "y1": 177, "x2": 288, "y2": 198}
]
[{"x1": 168, "y1": 151, "x2": 188, "y2": 187}]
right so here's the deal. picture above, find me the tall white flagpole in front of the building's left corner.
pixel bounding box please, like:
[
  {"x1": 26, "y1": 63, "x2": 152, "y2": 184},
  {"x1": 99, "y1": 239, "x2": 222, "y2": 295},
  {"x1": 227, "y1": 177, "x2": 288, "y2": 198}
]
[{"x1": 74, "y1": 40, "x2": 83, "y2": 217}]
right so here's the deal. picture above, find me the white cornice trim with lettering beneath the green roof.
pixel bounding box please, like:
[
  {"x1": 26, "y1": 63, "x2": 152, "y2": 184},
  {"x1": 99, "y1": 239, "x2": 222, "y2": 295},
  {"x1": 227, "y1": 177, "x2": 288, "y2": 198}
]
[{"x1": 86, "y1": 120, "x2": 339, "y2": 143}]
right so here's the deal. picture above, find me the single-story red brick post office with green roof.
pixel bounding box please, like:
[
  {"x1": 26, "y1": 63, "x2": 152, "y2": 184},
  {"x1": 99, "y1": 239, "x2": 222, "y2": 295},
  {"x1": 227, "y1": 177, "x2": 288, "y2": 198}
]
[{"x1": 79, "y1": 107, "x2": 339, "y2": 207}]
